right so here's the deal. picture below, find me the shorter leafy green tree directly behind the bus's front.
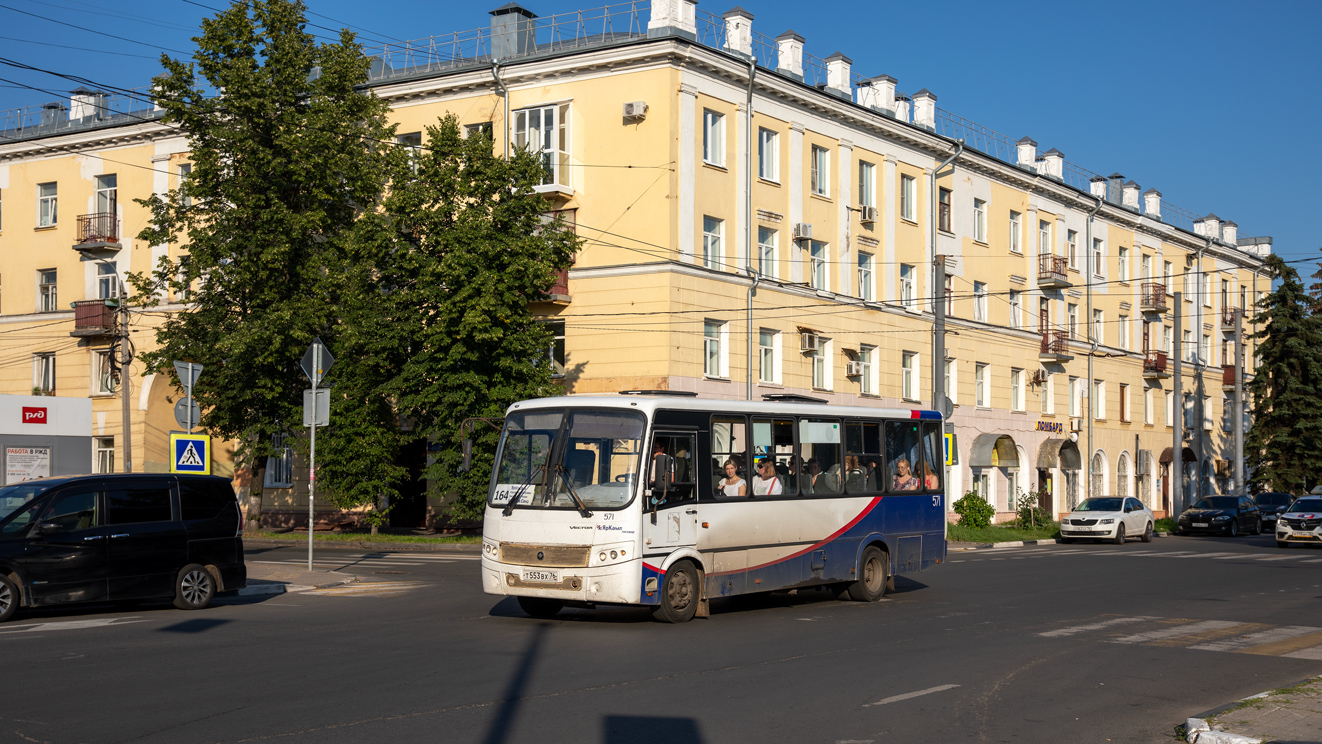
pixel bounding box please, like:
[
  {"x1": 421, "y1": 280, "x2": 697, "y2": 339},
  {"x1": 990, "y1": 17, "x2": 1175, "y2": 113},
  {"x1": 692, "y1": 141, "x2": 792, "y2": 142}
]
[{"x1": 334, "y1": 115, "x2": 579, "y2": 519}]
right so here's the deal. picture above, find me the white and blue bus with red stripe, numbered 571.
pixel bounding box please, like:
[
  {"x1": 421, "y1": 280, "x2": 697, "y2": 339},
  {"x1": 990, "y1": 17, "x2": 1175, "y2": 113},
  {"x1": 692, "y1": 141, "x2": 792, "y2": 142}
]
[{"x1": 483, "y1": 391, "x2": 945, "y2": 622}]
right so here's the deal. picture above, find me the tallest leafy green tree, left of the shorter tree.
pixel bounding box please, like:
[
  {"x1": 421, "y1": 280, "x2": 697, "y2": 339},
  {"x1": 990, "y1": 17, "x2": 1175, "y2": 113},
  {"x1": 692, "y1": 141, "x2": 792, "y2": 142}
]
[{"x1": 132, "y1": 0, "x2": 394, "y2": 523}]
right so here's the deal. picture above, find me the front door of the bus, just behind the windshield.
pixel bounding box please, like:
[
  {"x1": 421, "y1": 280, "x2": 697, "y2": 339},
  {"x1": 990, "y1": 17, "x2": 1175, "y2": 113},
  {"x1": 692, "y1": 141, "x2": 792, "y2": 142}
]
[{"x1": 642, "y1": 432, "x2": 698, "y2": 548}]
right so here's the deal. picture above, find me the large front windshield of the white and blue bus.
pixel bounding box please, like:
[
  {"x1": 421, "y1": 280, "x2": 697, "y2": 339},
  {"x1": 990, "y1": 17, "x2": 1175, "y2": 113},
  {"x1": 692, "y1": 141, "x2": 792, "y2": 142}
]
[{"x1": 490, "y1": 410, "x2": 645, "y2": 509}]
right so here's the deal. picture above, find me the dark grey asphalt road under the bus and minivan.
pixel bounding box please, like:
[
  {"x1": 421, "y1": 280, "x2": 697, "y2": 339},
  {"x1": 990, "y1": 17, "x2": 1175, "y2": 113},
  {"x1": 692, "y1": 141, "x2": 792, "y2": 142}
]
[{"x1": 0, "y1": 537, "x2": 1322, "y2": 744}]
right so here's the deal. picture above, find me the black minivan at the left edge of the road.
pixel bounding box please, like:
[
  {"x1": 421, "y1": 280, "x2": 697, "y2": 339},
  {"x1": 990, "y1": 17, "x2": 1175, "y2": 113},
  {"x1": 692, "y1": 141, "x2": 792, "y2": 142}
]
[{"x1": 0, "y1": 473, "x2": 247, "y2": 622}]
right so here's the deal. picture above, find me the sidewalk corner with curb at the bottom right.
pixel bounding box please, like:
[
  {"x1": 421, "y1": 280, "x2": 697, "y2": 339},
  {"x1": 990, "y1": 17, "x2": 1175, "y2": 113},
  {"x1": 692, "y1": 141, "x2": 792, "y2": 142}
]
[{"x1": 1183, "y1": 677, "x2": 1322, "y2": 744}]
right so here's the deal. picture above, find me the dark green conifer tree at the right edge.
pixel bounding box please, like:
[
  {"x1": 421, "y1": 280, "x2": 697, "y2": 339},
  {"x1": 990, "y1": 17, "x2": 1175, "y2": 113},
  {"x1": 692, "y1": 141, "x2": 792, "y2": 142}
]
[{"x1": 1244, "y1": 255, "x2": 1322, "y2": 493}]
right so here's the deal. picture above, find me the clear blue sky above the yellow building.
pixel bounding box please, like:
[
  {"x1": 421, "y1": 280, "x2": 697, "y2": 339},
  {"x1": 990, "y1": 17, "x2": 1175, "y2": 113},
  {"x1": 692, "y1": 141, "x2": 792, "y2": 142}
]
[{"x1": 0, "y1": 0, "x2": 1322, "y2": 266}]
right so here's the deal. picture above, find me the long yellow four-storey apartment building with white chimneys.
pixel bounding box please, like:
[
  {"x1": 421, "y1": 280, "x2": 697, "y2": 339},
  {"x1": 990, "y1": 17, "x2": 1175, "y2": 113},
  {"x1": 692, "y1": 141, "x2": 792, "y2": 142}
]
[{"x1": 0, "y1": 0, "x2": 1270, "y2": 522}]
